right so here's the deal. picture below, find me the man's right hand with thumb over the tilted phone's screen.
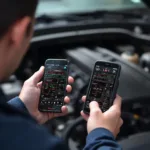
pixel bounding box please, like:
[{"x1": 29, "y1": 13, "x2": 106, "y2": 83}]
[{"x1": 81, "y1": 96, "x2": 123, "y2": 137}]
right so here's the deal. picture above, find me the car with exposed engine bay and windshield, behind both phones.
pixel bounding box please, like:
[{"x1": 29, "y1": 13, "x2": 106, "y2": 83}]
[{"x1": 1, "y1": 0, "x2": 150, "y2": 150}]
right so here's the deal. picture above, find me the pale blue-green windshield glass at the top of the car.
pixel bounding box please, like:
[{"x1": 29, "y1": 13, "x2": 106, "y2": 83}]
[{"x1": 37, "y1": 0, "x2": 145, "y2": 15}]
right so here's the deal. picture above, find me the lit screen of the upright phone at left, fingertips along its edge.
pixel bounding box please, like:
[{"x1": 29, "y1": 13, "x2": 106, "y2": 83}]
[{"x1": 40, "y1": 62, "x2": 68, "y2": 110}]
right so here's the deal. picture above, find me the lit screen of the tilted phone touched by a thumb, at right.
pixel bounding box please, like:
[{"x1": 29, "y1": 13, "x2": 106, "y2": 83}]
[{"x1": 85, "y1": 65, "x2": 118, "y2": 112}]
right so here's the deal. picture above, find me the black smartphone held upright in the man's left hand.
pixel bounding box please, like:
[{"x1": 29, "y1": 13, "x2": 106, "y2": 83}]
[{"x1": 39, "y1": 59, "x2": 69, "y2": 113}]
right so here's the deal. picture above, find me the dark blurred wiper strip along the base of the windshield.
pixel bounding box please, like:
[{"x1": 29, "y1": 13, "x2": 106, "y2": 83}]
[{"x1": 36, "y1": 10, "x2": 146, "y2": 24}]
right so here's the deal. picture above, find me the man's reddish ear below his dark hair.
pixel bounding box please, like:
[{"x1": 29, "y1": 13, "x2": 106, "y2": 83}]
[{"x1": 9, "y1": 17, "x2": 32, "y2": 46}]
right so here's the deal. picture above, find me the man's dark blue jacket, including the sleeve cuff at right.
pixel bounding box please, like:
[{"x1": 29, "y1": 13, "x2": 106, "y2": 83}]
[{"x1": 0, "y1": 97, "x2": 121, "y2": 150}]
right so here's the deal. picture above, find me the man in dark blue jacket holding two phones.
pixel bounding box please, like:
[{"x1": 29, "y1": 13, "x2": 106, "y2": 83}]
[{"x1": 0, "y1": 0, "x2": 123, "y2": 150}]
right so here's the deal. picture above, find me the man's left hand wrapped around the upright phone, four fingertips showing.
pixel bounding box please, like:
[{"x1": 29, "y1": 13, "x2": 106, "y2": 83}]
[{"x1": 19, "y1": 67, "x2": 74, "y2": 124}]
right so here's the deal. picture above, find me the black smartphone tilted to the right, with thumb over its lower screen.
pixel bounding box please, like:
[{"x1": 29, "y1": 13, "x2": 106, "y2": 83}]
[{"x1": 83, "y1": 61, "x2": 121, "y2": 114}]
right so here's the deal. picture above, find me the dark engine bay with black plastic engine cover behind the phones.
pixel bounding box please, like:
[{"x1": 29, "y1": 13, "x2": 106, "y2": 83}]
[{"x1": 1, "y1": 24, "x2": 150, "y2": 150}]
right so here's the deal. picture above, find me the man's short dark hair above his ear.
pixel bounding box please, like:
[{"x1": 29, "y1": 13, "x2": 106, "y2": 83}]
[{"x1": 0, "y1": 0, "x2": 38, "y2": 38}]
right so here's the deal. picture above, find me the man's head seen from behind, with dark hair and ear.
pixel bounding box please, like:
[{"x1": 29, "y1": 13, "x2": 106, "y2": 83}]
[{"x1": 0, "y1": 0, "x2": 38, "y2": 80}]
